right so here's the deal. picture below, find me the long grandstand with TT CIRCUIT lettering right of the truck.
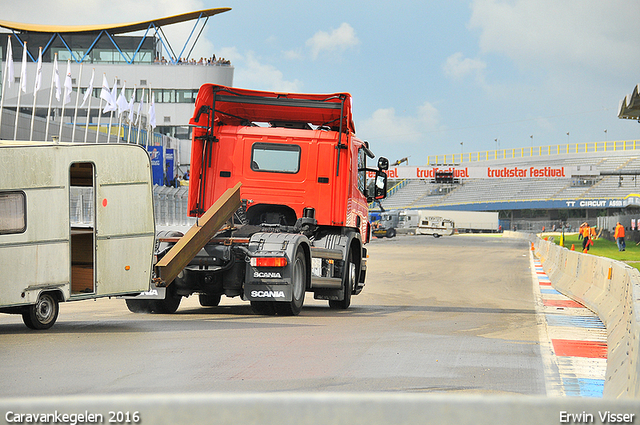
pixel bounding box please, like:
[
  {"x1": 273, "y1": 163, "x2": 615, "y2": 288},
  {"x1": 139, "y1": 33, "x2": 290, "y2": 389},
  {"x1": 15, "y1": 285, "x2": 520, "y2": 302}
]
[{"x1": 381, "y1": 141, "x2": 640, "y2": 230}]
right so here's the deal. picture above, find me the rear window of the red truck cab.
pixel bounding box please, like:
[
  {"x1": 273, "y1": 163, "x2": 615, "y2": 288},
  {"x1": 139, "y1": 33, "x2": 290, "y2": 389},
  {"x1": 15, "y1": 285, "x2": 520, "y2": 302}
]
[{"x1": 251, "y1": 143, "x2": 300, "y2": 173}]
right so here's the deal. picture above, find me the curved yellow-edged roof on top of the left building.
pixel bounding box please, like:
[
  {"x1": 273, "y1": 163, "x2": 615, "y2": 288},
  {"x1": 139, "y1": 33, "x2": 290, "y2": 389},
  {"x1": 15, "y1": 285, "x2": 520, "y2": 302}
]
[{"x1": 0, "y1": 7, "x2": 231, "y2": 34}]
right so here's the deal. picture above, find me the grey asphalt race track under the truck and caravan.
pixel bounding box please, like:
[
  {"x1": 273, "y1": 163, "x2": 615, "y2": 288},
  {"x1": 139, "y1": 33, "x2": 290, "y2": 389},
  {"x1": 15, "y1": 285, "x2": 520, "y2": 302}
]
[{"x1": 0, "y1": 236, "x2": 564, "y2": 397}]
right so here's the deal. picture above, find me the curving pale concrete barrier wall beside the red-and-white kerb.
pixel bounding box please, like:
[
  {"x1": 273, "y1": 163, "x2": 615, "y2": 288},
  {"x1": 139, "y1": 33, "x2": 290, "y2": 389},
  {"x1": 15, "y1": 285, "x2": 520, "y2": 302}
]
[{"x1": 533, "y1": 238, "x2": 640, "y2": 398}]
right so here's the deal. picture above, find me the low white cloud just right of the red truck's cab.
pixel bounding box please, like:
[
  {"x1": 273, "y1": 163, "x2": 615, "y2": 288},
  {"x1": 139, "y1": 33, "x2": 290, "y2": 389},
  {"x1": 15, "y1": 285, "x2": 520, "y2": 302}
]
[{"x1": 357, "y1": 102, "x2": 440, "y2": 144}]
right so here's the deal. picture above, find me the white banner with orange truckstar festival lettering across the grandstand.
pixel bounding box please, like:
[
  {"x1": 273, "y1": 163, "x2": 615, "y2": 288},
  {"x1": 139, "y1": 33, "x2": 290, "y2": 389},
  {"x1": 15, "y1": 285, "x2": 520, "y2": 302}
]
[{"x1": 368, "y1": 165, "x2": 577, "y2": 179}]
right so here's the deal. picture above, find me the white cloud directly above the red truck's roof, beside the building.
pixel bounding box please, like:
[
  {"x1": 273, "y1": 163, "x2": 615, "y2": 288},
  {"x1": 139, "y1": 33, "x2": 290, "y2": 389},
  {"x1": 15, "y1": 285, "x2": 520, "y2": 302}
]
[{"x1": 220, "y1": 47, "x2": 302, "y2": 93}]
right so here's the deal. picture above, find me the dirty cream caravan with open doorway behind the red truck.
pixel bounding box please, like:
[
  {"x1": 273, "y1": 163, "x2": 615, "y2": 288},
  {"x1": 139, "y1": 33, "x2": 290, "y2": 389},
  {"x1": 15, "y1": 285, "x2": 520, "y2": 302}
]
[{"x1": 0, "y1": 141, "x2": 155, "y2": 329}]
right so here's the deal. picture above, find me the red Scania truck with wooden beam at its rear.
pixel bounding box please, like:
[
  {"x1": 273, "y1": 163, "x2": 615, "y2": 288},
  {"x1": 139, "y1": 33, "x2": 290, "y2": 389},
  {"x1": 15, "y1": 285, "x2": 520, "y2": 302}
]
[{"x1": 122, "y1": 84, "x2": 389, "y2": 315}]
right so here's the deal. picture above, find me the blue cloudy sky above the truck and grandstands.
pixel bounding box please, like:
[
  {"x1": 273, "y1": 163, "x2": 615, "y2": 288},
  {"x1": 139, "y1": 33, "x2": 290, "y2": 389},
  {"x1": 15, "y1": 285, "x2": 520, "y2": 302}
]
[{"x1": 0, "y1": 0, "x2": 640, "y2": 165}]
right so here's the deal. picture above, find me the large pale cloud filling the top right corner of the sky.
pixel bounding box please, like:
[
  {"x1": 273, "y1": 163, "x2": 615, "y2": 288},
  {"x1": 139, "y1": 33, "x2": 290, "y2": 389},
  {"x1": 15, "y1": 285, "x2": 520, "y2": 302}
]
[{"x1": 470, "y1": 0, "x2": 640, "y2": 72}]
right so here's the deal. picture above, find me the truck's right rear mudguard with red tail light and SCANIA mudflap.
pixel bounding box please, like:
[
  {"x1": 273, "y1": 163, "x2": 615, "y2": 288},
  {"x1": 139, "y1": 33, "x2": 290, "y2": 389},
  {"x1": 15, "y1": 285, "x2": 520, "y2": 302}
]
[{"x1": 244, "y1": 233, "x2": 311, "y2": 302}]
